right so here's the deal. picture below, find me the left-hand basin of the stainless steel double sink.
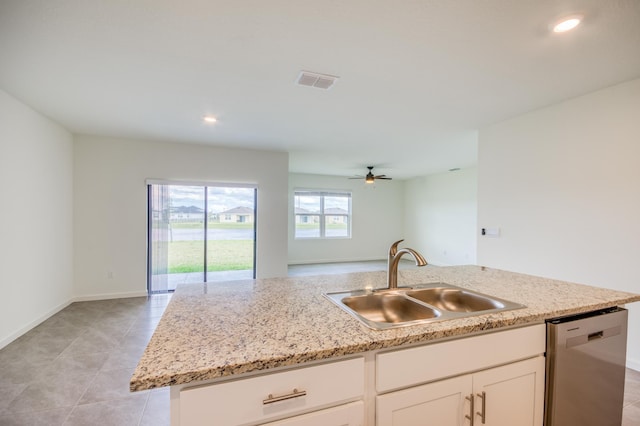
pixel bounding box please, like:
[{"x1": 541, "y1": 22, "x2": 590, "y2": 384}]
[{"x1": 342, "y1": 293, "x2": 440, "y2": 324}]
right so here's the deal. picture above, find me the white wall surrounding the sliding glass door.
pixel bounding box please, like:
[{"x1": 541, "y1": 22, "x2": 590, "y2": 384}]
[{"x1": 74, "y1": 135, "x2": 288, "y2": 299}]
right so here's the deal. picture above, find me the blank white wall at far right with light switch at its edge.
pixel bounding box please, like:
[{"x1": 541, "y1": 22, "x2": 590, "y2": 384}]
[{"x1": 478, "y1": 80, "x2": 640, "y2": 369}]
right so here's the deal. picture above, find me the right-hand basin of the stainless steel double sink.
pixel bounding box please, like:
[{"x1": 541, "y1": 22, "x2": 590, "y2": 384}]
[{"x1": 406, "y1": 287, "x2": 505, "y2": 312}]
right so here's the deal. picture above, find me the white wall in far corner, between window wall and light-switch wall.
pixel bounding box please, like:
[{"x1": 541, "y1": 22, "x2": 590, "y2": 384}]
[{"x1": 404, "y1": 167, "x2": 478, "y2": 266}]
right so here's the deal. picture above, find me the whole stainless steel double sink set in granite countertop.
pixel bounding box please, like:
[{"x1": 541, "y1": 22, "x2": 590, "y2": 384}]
[{"x1": 325, "y1": 283, "x2": 525, "y2": 330}]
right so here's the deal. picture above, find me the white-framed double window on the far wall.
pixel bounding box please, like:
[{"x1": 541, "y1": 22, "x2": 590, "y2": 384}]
[{"x1": 294, "y1": 191, "x2": 351, "y2": 238}]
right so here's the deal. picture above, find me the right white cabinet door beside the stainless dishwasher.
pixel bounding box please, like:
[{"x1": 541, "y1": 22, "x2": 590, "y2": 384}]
[{"x1": 473, "y1": 356, "x2": 545, "y2": 426}]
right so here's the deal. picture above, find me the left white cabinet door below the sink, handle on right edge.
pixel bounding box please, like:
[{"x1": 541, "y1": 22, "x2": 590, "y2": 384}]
[{"x1": 376, "y1": 375, "x2": 472, "y2": 426}]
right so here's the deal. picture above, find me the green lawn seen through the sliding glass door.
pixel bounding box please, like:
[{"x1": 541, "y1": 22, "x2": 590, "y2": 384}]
[{"x1": 169, "y1": 240, "x2": 253, "y2": 274}]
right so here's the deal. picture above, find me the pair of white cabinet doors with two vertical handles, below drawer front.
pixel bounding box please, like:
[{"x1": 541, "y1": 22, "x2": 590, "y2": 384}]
[{"x1": 376, "y1": 356, "x2": 544, "y2": 426}]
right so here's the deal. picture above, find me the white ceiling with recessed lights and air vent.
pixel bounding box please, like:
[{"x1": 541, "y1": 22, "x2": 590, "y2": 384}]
[{"x1": 0, "y1": 0, "x2": 640, "y2": 178}]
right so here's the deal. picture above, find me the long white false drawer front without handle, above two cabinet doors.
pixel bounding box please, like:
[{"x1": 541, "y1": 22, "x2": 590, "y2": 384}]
[{"x1": 376, "y1": 324, "x2": 546, "y2": 392}]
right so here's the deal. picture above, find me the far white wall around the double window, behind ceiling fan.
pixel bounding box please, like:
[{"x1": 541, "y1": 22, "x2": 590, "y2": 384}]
[{"x1": 288, "y1": 173, "x2": 405, "y2": 264}]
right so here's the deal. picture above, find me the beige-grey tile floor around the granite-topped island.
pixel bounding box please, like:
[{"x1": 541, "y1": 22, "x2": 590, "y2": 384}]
[{"x1": 0, "y1": 262, "x2": 640, "y2": 426}]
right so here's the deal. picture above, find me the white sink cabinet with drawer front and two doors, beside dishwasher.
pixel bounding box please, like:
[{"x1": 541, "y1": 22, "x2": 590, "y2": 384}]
[{"x1": 376, "y1": 324, "x2": 546, "y2": 426}]
